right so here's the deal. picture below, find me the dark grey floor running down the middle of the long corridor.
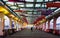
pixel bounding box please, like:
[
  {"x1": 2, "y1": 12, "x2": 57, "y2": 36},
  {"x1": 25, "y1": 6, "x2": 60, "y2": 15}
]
[{"x1": 6, "y1": 30, "x2": 60, "y2": 38}]
